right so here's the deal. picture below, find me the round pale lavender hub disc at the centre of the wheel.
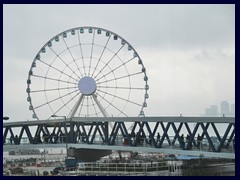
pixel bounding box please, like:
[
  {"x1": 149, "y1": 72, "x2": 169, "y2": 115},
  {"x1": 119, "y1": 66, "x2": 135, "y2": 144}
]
[{"x1": 78, "y1": 76, "x2": 97, "y2": 96}]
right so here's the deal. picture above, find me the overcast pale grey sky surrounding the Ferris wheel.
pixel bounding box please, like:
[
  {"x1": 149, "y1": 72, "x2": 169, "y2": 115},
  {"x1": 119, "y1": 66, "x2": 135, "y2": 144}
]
[{"x1": 3, "y1": 4, "x2": 235, "y2": 120}]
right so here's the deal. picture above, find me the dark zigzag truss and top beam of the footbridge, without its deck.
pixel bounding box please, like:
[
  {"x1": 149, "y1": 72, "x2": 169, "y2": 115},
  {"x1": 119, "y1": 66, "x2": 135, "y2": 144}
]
[{"x1": 3, "y1": 117, "x2": 235, "y2": 152}]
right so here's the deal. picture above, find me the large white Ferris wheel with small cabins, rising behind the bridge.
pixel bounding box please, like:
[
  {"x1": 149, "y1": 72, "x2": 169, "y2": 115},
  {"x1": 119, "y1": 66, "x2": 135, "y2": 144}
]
[{"x1": 26, "y1": 27, "x2": 149, "y2": 120}]
